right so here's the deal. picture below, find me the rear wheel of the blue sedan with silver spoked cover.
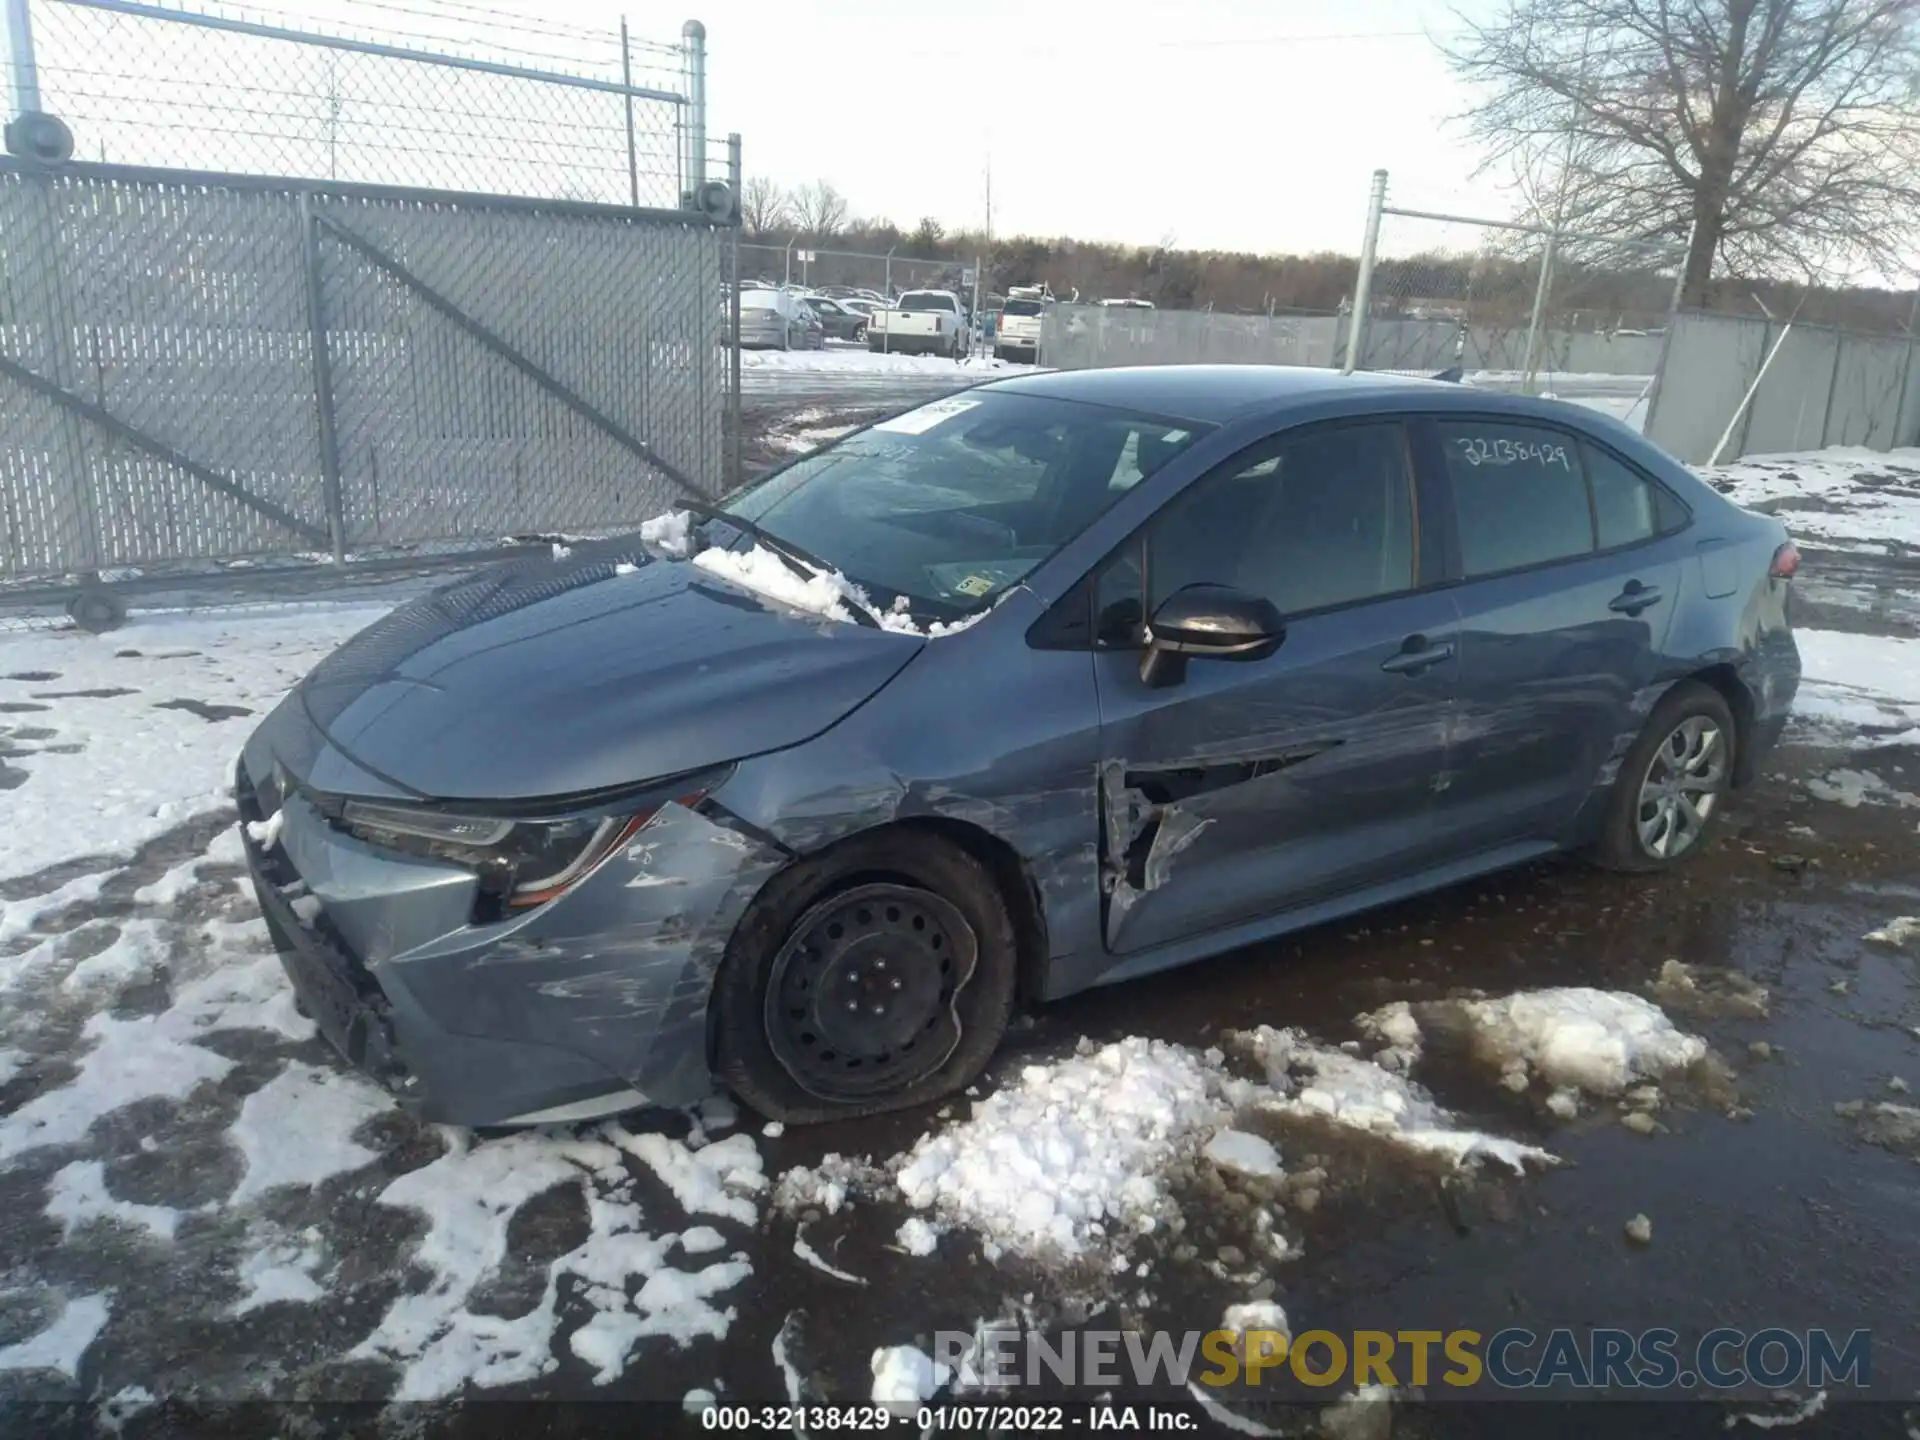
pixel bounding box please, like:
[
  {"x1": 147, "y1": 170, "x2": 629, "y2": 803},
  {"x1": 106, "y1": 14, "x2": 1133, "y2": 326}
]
[{"x1": 1596, "y1": 680, "x2": 1736, "y2": 872}]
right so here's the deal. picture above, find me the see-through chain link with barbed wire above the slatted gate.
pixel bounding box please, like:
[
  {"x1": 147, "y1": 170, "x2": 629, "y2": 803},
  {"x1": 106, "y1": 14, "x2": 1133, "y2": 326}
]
[{"x1": 6, "y1": 0, "x2": 701, "y2": 209}]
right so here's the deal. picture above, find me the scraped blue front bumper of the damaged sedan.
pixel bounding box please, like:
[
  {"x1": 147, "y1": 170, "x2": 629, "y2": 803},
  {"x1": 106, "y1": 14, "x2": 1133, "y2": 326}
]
[{"x1": 234, "y1": 745, "x2": 785, "y2": 1125}]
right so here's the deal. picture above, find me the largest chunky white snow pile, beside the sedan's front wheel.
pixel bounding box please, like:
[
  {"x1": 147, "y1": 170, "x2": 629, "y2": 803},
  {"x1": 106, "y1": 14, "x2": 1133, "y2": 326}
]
[{"x1": 897, "y1": 1037, "x2": 1225, "y2": 1256}]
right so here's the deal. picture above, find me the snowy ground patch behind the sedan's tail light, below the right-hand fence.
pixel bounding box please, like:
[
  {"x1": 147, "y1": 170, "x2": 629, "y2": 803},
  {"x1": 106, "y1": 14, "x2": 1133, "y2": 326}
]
[{"x1": 1701, "y1": 445, "x2": 1920, "y2": 553}]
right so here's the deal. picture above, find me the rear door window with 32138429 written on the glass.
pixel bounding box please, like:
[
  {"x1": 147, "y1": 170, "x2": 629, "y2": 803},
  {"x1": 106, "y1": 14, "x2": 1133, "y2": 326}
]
[{"x1": 1438, "y1": 420, "x2": 1594, "y2": 576}]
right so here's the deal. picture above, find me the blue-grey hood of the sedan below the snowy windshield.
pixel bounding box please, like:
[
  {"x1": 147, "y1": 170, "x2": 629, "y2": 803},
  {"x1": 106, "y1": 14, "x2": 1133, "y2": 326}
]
[{"x1": 290, "y1": 547, "x2": 925, "y2": 801}]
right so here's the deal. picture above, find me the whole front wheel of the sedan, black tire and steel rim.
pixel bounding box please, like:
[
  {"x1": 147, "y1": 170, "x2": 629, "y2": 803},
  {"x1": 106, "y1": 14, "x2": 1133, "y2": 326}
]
[{"x1": 712, "y1": 831, "x2": 1018, "y2": 1123}]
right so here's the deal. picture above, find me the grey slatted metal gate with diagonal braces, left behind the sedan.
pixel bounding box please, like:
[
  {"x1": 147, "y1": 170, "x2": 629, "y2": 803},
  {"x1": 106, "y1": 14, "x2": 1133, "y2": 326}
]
[{"x1": 0, "y1": 159, "x2": 728, "y2": 599}]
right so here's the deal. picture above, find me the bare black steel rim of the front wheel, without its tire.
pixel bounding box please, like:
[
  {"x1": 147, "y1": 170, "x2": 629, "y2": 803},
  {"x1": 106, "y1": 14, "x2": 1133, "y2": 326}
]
[{"x1": 764, "y1": 885, "x2": 979, "y2": 1100}]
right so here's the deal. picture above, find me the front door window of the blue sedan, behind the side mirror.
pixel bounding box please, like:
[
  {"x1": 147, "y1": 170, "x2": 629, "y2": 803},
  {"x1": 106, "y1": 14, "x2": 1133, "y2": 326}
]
[{"x1": 1146, "y1": 424, "x2": 1415, "y2": 614}]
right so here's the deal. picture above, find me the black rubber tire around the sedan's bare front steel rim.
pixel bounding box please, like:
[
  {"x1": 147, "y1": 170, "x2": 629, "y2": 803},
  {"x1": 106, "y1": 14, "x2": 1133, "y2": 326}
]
[{"x1": 712, "y1": 831, "x2": 1020, "y2": 1125}]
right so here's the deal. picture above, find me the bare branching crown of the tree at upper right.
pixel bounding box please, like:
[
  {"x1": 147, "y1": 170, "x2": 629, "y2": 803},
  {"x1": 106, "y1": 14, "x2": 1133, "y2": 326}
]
[{"x1": 1448, "y1": 0, "x2": 1920, "y2": 305}]
